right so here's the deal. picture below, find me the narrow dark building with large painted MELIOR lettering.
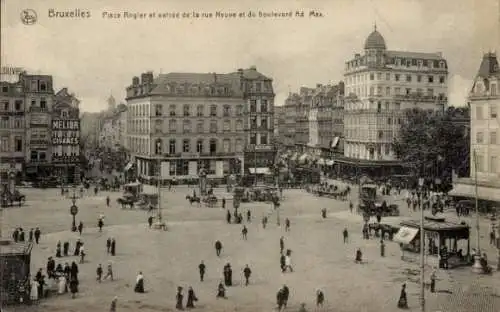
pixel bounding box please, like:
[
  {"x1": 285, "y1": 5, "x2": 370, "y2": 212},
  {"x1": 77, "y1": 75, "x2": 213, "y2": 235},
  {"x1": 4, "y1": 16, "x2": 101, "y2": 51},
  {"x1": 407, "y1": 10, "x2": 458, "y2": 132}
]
[{"x1": 51, "y1": 88, "x2": 82, "y2": 183}]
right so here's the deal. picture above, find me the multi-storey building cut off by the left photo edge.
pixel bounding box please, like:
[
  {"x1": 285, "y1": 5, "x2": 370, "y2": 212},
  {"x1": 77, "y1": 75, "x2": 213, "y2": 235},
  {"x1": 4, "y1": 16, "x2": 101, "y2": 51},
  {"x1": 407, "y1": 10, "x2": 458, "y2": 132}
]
[{"x1": 0, "y1": 81, "x2": 26, "y2": 181}]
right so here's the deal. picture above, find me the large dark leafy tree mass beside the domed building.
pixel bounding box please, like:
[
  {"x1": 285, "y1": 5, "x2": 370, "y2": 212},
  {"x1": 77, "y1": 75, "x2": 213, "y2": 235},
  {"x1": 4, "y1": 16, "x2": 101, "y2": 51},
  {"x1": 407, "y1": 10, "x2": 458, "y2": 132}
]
[{"x1": 393, "y1": 108, "x2": 470, "y2": 184}]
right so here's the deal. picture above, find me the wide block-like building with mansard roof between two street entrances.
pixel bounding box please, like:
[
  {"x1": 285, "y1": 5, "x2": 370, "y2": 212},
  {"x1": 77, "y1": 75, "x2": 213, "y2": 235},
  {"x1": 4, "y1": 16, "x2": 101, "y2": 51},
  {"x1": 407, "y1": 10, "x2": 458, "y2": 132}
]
[{"x1": 126, "y1": 67, "x2": 275, "y2": 180}]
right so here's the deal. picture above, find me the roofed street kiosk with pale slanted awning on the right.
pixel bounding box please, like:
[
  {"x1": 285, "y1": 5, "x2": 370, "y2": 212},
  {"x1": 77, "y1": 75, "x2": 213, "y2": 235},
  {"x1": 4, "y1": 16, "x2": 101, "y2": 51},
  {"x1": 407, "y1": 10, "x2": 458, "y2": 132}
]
[{"x1": 393, "y1": 217, "x2": 470, "y2": 268}]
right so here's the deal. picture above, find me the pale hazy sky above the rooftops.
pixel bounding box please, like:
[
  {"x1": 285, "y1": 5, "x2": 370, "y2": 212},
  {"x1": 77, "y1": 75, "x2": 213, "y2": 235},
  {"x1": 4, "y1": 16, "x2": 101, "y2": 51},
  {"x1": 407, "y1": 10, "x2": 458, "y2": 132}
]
[{"x1": 0, "y1": 0, "x2": 500, "y2": 111}]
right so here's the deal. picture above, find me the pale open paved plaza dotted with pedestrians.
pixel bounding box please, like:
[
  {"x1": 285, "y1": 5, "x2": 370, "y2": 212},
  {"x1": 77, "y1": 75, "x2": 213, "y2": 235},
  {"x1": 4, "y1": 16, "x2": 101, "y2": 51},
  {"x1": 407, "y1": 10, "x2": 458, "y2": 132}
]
[{"x1": 3, "y1": 187, "x2": 500, "y2": 312}]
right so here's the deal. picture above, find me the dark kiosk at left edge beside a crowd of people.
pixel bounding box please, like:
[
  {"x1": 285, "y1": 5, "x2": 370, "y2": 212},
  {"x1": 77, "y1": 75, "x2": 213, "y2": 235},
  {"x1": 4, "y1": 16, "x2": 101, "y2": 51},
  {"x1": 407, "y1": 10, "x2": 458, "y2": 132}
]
[{"x1": 0, "y1": 239, "x2": 33, "y2": 304}]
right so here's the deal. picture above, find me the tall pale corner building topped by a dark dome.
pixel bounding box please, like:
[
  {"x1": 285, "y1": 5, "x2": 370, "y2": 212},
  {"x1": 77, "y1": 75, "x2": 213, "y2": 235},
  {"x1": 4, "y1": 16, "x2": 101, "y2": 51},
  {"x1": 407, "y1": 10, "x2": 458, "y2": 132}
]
[{"x1": 340, "y1": 28, "x2": 448, "y2": 175}]
